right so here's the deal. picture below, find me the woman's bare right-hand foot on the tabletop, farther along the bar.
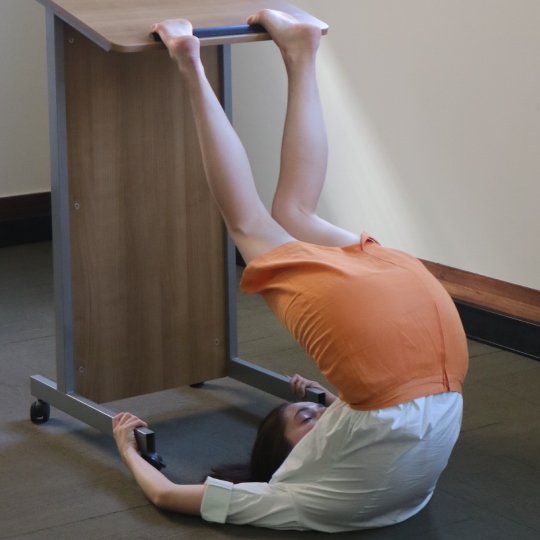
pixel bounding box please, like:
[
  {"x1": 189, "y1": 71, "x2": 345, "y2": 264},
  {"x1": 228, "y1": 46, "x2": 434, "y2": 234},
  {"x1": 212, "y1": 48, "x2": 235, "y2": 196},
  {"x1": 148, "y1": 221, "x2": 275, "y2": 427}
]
[{"x1": 247, "y1": 9, "x2": 322, "y2": 60}]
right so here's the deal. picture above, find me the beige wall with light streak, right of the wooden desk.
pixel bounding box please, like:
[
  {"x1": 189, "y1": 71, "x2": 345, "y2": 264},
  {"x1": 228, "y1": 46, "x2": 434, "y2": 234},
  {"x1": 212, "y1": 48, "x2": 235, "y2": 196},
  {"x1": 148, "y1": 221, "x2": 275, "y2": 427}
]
[{"x1": 233, "y1": 0, "x2": 540, "y2": 289}]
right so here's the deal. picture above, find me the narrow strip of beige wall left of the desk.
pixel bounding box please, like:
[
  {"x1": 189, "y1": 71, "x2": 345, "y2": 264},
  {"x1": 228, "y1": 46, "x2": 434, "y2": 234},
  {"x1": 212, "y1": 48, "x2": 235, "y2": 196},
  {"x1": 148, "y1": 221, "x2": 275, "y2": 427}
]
[{"x1": 0, "y1": 0, "x2": 50, "y2": 197}]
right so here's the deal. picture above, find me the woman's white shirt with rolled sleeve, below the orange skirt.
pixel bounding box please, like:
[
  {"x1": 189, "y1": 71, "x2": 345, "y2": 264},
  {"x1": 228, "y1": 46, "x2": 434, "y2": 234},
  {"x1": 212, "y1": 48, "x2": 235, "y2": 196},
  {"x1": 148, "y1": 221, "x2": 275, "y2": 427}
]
[{"x1": 201, "y1": 392, "x2": 463, "y2": 532}]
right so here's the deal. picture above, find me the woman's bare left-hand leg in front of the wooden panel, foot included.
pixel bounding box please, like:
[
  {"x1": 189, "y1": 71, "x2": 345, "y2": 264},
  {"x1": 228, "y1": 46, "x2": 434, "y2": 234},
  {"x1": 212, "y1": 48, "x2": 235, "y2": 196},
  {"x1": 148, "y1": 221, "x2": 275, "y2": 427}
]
[{"x1": 152, "y1": 20, "x2": 295, "y2": 262}]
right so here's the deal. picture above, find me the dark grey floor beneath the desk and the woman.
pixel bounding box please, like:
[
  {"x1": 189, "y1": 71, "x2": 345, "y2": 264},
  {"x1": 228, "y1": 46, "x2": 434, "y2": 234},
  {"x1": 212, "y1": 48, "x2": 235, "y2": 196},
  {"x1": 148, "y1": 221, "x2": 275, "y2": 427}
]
[{"x1": 0, "y1": 243, "x2": 540, "y2": 540}]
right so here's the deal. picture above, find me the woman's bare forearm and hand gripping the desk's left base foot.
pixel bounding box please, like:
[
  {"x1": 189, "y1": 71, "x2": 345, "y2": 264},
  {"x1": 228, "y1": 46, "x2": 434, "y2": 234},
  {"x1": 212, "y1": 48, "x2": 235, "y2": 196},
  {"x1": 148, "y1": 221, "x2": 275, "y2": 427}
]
[{"x1": 113, "y1": 413, "x2": 206, "y2": 515}]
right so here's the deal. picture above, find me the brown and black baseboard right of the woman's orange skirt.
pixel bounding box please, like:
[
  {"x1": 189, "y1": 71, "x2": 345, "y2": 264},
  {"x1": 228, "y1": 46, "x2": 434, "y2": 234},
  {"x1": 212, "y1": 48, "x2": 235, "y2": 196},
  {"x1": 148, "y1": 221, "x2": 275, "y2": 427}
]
[{"x1": 422, "y1": 261, "x2": 540, "y2": 360}]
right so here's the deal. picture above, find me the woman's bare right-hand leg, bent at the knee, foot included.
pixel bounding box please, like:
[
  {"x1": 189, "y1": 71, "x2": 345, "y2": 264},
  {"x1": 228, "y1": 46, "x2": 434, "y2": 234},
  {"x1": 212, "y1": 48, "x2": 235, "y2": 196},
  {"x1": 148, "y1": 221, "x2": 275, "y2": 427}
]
[{"x1": 248, "y1": 10, "x2": 359, "y2": 246}]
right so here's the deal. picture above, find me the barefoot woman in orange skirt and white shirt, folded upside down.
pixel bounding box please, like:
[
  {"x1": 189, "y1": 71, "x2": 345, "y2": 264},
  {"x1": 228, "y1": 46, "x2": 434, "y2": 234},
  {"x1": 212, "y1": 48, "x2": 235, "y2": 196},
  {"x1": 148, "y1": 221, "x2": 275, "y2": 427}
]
[{"x1": 113, "y1": 10, "x2": 467, "y2": 532}]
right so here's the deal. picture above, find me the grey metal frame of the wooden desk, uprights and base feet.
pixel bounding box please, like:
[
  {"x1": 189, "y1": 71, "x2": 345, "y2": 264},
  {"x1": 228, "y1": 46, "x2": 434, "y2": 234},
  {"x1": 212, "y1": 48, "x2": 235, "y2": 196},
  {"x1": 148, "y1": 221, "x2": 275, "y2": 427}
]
[{"x1": 30, "y1": 10, "x2": 325, "y2": 464}]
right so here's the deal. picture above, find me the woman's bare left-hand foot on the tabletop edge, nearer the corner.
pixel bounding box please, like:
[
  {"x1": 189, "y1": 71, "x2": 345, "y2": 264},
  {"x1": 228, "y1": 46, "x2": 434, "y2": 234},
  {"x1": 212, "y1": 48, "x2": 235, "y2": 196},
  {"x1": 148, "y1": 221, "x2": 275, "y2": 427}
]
[{"x1": 152, "y1": 19, "x2": 200, "y2": 71}]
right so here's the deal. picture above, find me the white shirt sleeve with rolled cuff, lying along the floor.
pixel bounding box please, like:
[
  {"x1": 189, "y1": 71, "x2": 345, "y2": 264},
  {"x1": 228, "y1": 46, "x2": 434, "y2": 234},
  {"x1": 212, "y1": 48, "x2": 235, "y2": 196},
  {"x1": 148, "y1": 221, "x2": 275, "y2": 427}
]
[{"x1": 201, "y1": 477, "x2": 305, "y2": 530}]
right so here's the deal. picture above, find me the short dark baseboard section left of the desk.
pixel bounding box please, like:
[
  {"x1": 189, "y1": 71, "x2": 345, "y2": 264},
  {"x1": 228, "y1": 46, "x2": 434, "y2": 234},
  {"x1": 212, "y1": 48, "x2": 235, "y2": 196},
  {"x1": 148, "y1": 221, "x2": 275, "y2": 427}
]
[{"x1": 0, "y1": 192, "x2": 52, "y2": 247}]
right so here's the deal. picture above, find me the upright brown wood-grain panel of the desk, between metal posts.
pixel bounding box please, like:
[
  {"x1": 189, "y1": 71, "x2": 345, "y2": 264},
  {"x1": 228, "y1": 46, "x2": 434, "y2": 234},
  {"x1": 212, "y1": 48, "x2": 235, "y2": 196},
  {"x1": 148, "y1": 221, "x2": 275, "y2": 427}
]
[{"x1": 65, "y1": 26, "x2": 227, "y2": 403}]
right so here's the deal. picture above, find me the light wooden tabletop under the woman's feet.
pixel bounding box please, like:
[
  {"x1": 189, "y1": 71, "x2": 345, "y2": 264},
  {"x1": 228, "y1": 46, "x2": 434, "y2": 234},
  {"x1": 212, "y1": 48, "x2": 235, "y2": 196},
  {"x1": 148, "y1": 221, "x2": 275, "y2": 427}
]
[{"x1": 37, "y1": 0, "x2": 327, "y2": 52}]
